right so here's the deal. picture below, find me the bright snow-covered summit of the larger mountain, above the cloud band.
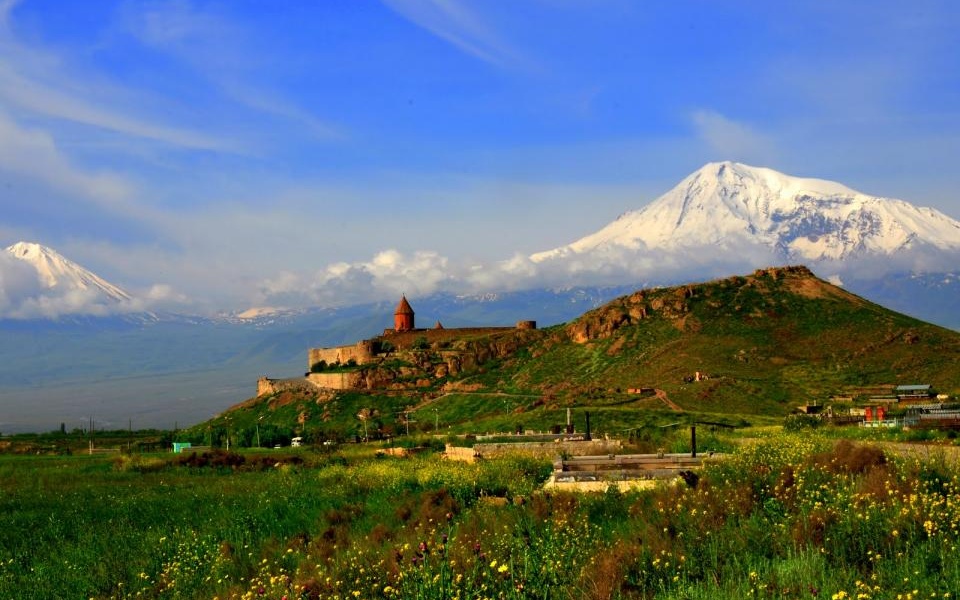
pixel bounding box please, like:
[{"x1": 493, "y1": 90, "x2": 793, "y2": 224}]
[{"x1": 530, "y1": 162, "x2": 960, "y2": 262}]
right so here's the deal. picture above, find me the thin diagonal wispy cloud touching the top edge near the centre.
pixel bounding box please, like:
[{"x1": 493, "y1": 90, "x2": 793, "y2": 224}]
[{"x1": 382, "y1": 0, "x2": 530, "y2": 68}]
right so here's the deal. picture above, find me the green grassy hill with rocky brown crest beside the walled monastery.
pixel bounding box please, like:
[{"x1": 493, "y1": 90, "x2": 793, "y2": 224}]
[{"x1": 191, "y1": 267, "x2": 960, "y2": 439}]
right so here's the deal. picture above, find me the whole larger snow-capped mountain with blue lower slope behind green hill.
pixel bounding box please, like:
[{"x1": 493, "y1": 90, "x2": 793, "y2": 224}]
[{"x1": 530, "y1": 162, "x2": 960, "y2": 329}]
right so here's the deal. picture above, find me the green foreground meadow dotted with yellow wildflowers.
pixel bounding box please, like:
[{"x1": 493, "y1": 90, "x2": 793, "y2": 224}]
[{"x1": 0, "y1": 433, "x2": 960, "y2": 600}]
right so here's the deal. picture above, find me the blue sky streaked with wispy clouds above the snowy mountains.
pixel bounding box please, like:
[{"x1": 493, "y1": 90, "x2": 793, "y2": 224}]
[{"x1": 0, "y1": 0, "x2": 960, "y2": 311}]
